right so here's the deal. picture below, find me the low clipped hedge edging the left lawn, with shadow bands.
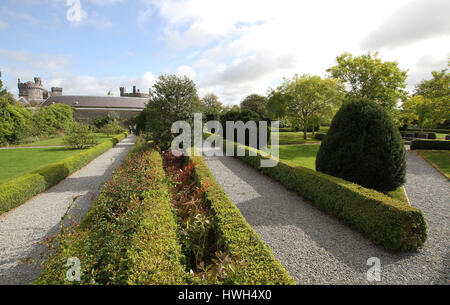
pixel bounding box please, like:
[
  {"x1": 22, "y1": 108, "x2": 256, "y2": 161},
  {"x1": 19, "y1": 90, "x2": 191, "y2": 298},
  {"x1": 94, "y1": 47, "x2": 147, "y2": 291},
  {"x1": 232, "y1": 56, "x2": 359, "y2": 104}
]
[{"x1": 0, "y1": 133, "x2": 127, "y2": 215}]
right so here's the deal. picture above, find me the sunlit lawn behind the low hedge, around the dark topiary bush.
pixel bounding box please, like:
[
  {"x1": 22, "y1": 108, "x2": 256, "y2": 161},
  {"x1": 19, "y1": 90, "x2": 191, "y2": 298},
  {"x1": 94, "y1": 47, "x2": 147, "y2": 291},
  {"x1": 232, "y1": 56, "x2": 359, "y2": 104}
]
[{"x1": 279, "y1": 144, "x2": 408, "y2": 202}]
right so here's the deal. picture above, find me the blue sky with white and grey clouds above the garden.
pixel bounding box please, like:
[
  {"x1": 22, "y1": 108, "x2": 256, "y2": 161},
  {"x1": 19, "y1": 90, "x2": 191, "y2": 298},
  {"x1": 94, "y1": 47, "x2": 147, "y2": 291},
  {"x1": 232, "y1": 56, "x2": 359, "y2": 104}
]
[{"x1": 0, "y1": 0, "x2": 450, "y2": 105}]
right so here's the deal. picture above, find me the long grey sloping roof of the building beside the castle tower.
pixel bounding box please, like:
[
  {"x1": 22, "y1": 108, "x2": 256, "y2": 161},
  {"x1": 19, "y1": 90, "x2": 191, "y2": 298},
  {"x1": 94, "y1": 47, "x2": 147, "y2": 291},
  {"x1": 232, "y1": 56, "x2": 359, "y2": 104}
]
[{"x1": 41, "y1": 95, "x2": 148, "y2": 109}]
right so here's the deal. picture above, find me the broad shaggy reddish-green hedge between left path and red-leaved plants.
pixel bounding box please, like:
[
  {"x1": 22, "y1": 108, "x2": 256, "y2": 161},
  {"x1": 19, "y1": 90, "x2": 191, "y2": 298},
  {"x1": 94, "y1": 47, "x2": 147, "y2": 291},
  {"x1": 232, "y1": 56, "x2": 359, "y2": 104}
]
[{"x1": 35, "y1": 144, "x2": 190, "y2": 285}]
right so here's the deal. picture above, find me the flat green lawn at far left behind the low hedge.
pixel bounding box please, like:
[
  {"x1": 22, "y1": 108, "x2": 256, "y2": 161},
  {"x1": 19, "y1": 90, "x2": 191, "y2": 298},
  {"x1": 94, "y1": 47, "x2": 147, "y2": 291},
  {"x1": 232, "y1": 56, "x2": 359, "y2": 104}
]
[{"x1": 0, "y1": 147, "x2": 84, "y2": 183}]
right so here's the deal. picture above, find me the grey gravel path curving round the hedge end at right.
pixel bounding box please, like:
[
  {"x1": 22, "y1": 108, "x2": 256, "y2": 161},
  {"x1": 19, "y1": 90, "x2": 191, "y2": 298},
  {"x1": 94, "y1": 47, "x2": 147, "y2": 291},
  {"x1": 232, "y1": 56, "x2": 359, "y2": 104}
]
[{"x1": 204, "y1": 146, "x2": 450, "y2": 284}]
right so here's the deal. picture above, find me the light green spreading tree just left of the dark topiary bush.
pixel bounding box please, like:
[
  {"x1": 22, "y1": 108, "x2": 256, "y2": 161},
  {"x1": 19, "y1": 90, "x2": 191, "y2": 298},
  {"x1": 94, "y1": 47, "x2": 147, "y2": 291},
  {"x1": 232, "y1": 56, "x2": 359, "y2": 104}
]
[{"x1": 283, "y1": 75, "x2": 341, "y2": 139}]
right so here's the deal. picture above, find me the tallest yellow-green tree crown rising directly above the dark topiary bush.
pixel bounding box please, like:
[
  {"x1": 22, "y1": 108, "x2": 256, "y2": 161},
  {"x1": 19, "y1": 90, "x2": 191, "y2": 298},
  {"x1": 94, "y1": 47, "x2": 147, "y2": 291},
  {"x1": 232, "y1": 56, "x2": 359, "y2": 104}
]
[{"x1": 327, "y1": 53, "x2": 407, "y2": 114}]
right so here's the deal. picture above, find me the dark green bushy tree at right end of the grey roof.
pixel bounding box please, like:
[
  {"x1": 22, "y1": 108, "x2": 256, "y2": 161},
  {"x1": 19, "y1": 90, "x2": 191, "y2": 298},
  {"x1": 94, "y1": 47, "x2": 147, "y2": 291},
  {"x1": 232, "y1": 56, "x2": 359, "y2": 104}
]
[{"x1": 137, "y1": 75, "x2": 200, "y2": 149}]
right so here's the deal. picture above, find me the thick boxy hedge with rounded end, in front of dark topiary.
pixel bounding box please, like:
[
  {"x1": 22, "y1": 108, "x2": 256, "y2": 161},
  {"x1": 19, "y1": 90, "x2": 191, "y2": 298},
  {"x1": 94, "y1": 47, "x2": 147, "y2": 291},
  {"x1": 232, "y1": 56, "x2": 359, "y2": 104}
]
[{"x1": 224, "y1": 140, "x2": 427, "y2": 251}]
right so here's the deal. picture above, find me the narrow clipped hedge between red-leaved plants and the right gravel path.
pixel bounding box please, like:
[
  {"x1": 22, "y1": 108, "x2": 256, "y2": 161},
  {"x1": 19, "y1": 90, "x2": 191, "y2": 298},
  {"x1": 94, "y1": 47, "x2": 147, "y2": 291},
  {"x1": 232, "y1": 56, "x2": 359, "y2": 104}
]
[{"x1": 189, "y1": 151, "x2": 295, "y2": 285}]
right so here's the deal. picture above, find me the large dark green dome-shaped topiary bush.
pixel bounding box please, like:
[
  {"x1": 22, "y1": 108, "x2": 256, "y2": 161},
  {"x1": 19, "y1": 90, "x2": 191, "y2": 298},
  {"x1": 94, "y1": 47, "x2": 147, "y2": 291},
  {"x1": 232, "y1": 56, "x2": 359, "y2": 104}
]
[{"x1": 316, "y1": 99, "x2": 406, "y2": 192}]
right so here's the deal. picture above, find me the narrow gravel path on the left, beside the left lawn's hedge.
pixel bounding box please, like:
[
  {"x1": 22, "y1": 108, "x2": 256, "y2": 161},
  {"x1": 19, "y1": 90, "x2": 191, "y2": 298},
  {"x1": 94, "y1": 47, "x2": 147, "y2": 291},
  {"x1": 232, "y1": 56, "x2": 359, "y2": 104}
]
[{"x1": 0, "y1": 136, "x2": 135, "y2": 285}]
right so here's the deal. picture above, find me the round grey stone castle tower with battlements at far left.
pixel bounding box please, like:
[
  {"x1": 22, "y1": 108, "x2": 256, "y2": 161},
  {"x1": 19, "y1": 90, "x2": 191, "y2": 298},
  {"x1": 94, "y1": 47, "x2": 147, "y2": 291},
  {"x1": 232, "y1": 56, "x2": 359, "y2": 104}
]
[{"x1": 17, "y1": 77, "x2": 62, "y2": 104}]
